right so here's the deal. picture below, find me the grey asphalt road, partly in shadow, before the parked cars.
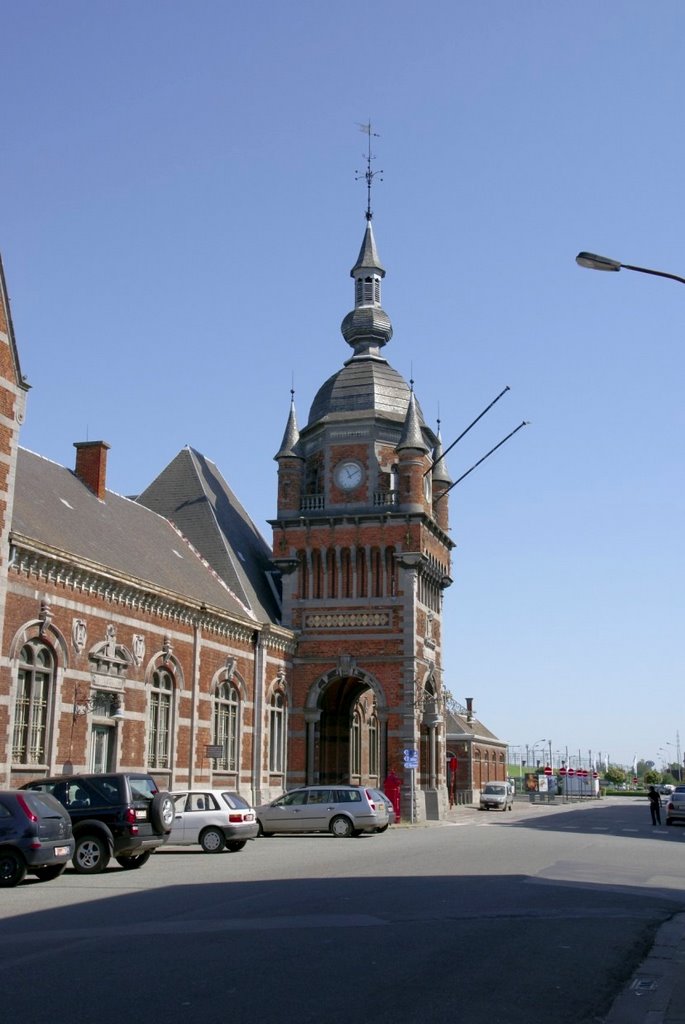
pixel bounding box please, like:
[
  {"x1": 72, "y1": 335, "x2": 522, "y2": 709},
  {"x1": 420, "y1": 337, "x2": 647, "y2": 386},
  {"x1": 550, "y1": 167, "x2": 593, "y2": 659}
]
[{"x1": 0, "y1": 799, "x2": 685, "y2": 1024}]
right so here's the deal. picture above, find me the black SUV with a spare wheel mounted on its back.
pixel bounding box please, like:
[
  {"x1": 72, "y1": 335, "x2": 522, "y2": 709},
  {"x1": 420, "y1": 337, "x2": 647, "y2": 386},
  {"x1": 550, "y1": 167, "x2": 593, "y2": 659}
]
[{"x1": 22, "y1": 772, "x2": 174, "y2": 874}]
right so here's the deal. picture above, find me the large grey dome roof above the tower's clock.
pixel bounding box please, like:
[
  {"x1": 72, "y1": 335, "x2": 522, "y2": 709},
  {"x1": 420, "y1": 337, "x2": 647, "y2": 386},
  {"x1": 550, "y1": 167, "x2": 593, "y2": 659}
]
[{"x1": 307, "y1": 356, "x2": 424, "y2": 426}]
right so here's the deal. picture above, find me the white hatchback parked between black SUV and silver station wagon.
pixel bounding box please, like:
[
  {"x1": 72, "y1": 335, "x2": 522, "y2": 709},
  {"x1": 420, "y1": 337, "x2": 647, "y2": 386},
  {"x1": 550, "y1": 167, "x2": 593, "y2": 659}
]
[{"x1": 169, "y1": 790, "x2": 259, "y2": 853}]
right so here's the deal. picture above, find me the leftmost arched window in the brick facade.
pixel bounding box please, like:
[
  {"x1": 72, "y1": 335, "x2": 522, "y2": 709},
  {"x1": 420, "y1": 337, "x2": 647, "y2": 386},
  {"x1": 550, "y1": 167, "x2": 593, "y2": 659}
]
[{"x1": 12, "y1": 640, "x2": 54, "y2": 764}]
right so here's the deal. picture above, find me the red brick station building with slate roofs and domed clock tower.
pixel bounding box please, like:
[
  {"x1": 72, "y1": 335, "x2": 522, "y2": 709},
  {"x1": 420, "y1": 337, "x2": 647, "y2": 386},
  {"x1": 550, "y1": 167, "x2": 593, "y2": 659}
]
[{"x1": 0, "y1": 205, "x2": 501, "y2": 819}]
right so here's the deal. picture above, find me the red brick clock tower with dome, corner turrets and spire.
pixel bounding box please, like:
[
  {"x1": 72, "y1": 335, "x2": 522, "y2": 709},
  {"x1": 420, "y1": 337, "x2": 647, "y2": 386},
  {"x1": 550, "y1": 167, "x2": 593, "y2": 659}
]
[{"x1": 271, "y1": 199, "x2": 454, "y2": 820}]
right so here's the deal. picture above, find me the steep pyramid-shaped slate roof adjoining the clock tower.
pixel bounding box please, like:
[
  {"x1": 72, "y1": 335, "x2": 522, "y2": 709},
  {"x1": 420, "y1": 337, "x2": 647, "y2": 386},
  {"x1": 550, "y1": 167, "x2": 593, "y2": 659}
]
[{"x1": 137, "y1": 446, "x2": 281, "y2": 623}]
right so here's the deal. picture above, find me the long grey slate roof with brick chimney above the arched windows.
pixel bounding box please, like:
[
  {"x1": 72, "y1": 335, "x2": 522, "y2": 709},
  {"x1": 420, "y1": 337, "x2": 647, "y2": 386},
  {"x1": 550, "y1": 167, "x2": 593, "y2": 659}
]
[{"x1": 10, "y1": 449, "x2": 254, "y2": 622}]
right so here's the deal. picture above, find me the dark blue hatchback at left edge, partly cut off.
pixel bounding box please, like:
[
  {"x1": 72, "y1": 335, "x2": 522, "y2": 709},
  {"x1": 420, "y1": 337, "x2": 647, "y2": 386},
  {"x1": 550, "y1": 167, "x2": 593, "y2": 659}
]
[{"x1": 0, "y1": 790, "x2": 74, "y2": 889}]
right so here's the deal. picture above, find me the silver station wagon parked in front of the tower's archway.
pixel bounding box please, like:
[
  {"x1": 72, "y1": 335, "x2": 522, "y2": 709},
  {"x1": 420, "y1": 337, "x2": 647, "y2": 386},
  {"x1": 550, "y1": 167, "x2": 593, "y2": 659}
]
[{"x1": 257, "y1": 785, "x2": 388, "y2": 839}]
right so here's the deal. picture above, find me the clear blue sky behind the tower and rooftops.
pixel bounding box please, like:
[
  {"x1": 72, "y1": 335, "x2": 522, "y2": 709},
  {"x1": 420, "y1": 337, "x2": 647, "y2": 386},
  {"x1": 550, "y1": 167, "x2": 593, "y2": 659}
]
[{"x1": 0, "y1": 0, "x2": 685, "y2": 763}]
